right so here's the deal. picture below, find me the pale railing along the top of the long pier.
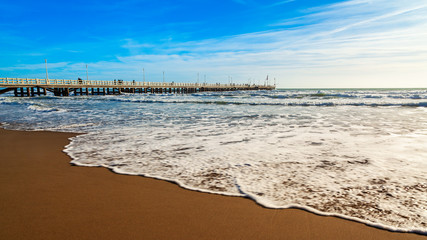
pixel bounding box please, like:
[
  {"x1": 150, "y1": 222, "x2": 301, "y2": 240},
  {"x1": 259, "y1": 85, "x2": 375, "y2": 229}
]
[{"x1": 0, "y1": 78, "x2": 274, "y2": 89}]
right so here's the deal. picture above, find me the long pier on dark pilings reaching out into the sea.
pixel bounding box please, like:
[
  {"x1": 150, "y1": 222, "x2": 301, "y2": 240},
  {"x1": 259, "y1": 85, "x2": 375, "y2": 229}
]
[{"x1": 0, "y1": 78, "x2": 275, "y2": 97}]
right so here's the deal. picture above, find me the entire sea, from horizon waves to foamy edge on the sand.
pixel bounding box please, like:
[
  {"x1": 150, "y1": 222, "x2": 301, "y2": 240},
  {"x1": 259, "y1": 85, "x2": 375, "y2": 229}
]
[{"x1": 0, "y1": 89, "x2": 427, "y2": 234}]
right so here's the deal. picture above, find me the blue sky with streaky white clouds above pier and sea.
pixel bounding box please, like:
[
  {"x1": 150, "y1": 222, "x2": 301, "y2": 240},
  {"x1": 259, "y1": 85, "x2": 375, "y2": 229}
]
[{"x1": 0, "y1": 0, "x2": 427, "y2": 88}]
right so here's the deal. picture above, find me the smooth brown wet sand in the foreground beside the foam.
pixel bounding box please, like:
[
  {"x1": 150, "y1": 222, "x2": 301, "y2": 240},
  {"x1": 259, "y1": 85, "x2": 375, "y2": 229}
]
[{"x1": 0, "y1": 129, "x2": 427, "y2": 240}]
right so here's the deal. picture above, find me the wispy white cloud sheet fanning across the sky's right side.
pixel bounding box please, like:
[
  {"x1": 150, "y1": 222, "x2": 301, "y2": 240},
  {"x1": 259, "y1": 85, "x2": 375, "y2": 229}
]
[{"x1": 0, "y1": 0, "x2": 427, "y2": 87}]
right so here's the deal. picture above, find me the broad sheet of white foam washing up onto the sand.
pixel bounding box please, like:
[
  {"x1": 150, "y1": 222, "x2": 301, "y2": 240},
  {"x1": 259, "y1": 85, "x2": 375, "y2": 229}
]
[{"x1": 66, "y1": 104, "x2": 427, "y2": 232}]
